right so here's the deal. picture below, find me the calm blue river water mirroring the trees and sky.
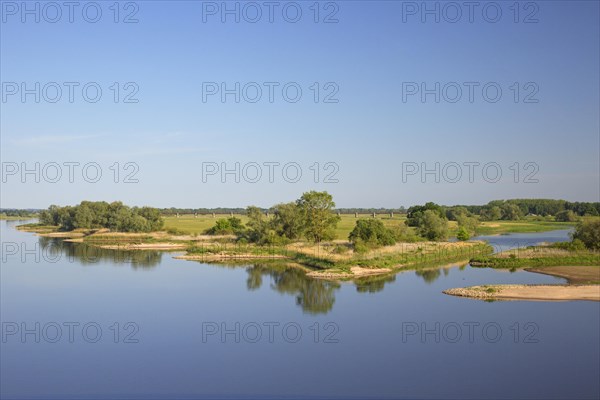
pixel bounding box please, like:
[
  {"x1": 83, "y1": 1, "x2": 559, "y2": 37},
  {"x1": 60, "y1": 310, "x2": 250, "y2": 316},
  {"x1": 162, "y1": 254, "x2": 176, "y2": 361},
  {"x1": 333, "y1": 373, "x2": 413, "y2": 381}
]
[{"x1": 0, "y1": 221, "x2": 600, "y2": 399}]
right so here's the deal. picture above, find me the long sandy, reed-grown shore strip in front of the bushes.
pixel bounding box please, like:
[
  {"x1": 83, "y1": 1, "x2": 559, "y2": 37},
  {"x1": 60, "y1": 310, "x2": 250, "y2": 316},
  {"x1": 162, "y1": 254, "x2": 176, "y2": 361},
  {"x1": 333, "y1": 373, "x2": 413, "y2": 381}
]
[{"x1": 17, "y1": 222, "x2": 492, "y2": 281}]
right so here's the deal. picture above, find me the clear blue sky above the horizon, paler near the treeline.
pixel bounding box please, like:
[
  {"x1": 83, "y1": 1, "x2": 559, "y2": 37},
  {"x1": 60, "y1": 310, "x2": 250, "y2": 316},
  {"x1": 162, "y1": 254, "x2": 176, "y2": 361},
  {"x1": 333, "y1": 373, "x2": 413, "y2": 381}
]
[{"x1": 0, "y1": 1, "x2": 600, "y2": 208}]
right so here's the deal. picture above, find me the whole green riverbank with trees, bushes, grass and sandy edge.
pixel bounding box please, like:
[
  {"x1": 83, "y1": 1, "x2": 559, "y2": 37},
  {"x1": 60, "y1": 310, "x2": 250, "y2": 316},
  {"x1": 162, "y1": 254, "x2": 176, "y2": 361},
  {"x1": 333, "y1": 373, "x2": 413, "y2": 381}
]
[{"x1": 15, "y1": 195, "x2": 600, "y2": 276}]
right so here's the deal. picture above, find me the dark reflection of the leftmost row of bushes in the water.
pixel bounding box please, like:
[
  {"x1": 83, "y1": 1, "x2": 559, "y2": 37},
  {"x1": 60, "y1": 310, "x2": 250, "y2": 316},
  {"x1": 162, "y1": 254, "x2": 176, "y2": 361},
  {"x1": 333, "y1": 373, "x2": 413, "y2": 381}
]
[{"x1": 39, "y1": 237, "x2": 162, "y2": 269}]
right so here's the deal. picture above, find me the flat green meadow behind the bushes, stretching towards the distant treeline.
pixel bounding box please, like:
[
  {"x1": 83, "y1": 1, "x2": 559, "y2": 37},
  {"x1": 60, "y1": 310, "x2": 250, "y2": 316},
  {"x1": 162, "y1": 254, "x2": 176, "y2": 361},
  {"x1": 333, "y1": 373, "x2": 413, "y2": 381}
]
[{"x1": 165, "y1": 214, "x2": 574, "y2": 240}]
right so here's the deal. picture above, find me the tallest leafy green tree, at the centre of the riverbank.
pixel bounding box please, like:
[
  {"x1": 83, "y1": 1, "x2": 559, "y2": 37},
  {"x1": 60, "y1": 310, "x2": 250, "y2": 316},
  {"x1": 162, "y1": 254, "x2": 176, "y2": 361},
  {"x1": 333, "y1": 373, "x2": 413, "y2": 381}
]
[{"x1": 296, "y1": 190, "x2": 340, "y2": 243}]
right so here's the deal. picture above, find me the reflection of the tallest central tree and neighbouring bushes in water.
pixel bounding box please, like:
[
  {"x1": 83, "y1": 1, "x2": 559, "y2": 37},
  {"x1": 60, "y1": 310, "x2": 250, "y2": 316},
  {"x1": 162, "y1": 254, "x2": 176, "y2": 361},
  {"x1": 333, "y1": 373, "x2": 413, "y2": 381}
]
[{"x1": 246, "y1": 264, "x2": 340, "y2": 314}]
